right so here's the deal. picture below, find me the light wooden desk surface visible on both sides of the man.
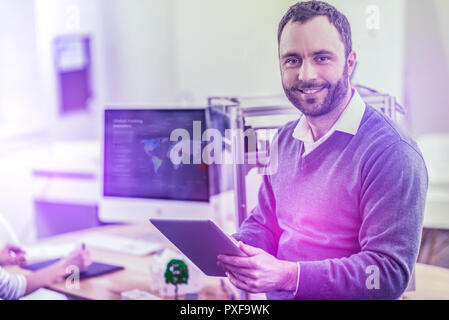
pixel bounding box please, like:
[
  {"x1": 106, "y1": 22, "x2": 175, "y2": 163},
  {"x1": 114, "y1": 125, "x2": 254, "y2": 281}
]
[{"x1": 7, "y1": 224, "x2": 449, "y2": 300}]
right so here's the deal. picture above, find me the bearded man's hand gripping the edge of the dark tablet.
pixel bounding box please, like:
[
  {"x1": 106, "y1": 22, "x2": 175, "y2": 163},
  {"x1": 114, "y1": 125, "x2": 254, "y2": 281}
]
[{"x1": 217, "y1": 242, "x2": 298, "y2": 293}]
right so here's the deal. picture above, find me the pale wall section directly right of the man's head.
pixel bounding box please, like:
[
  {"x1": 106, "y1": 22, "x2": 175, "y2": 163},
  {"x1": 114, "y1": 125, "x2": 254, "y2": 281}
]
[{"x1": 328, "y1": 0, "x2": 405, "y2": 104}]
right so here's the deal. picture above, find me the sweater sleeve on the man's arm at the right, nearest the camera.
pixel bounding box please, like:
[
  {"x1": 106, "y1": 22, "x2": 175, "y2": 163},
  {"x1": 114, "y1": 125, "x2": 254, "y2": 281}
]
[{"x1": 295, "y1": 140, "x2": 428, "y2": 299}]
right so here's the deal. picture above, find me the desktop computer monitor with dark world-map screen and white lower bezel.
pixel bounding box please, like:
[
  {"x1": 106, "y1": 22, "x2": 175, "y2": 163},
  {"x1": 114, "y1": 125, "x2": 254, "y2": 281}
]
[{"x1": 99, "y1": 108, "x2": 211, "y2": 222}]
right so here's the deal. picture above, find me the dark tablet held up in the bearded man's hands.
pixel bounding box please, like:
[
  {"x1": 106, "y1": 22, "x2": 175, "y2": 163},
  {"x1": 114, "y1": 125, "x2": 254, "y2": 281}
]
[{"x1": 150, "y1": 218, "x2": 246, "y2": 277}]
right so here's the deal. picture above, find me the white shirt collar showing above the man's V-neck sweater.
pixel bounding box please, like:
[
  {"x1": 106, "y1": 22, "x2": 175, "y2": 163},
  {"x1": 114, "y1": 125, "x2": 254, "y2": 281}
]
[{"x1": 292, "y1": 89, "x2": 366, "y2": 157}]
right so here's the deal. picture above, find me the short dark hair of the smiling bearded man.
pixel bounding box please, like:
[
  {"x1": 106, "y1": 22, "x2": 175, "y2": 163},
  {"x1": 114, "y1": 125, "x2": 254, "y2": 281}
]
[{"x1": 278, "y1": 1, "x2": 352, "y2": 58}]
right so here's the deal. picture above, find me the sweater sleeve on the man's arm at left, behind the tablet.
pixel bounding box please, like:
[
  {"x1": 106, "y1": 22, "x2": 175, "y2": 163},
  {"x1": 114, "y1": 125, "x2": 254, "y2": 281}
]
[{"x1": 233, "y1": 171, "x2": 280, "y2": 255}]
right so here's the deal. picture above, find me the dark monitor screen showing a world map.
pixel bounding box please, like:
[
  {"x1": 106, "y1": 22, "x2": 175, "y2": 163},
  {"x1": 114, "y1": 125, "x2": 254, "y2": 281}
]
[{"x1": 103, "y1": 109, "x2": 209, "y2": 202}]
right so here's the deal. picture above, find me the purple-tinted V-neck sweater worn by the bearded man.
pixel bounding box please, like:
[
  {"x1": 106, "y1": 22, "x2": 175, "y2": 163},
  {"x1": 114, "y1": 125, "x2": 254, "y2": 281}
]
[{"x1": 235, "y1": 106, "x2": 428, "y2": 299}]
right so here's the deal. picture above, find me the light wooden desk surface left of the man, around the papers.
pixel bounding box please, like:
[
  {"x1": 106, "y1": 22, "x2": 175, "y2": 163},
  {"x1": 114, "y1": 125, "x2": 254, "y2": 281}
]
[{"x1": 7, "y1": 224, "x2": 228, "y2": 300}]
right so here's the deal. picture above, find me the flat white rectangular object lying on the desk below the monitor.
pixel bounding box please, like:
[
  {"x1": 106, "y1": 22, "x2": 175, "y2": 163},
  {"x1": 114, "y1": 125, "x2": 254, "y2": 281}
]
[{"x1": 83, "y1": 234, "x2": 164, "y2": 256}]
